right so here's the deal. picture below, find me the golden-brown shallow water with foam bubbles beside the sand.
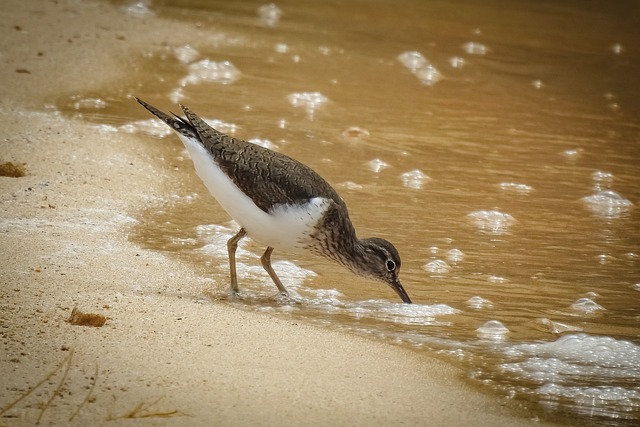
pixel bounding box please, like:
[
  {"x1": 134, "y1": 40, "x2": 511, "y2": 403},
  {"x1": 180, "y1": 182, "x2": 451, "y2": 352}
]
[{"x1": 60, "y1": 0, "x2": 640, "y2": 425}]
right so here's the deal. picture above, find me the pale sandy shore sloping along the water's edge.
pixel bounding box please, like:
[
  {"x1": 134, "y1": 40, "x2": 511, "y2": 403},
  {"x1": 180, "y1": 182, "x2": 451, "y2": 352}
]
[{"x1": 0, "y1": 0, "x2": 556, "y2": 426}]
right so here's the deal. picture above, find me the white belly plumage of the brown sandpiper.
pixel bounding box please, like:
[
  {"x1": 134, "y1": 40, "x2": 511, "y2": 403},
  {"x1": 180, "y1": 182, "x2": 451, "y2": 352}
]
[{"x1": 178, "y1": 134, "x2": 332, "y2": 251}]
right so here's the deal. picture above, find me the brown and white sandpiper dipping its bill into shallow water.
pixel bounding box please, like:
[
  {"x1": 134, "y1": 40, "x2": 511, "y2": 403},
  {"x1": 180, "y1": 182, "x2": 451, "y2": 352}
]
[{"x1": 136, "y1": 98, "x2": 411, "y2": 304}]
